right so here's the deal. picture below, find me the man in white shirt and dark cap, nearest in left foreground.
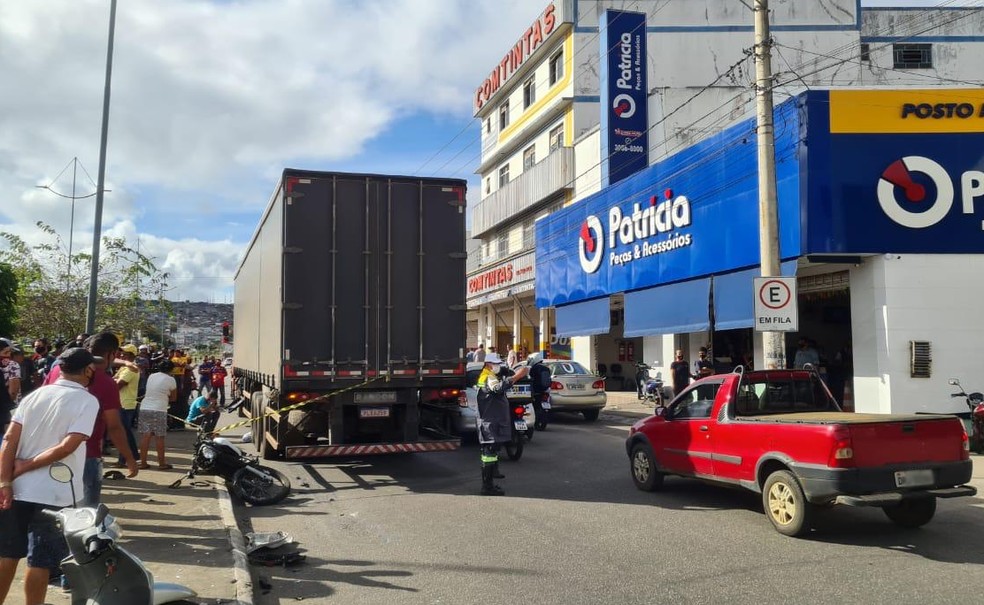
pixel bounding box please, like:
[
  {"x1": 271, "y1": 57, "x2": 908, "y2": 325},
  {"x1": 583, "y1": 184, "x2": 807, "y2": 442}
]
[{"x1": 0, "y1": 348, "x2": 102, "y2": 605}]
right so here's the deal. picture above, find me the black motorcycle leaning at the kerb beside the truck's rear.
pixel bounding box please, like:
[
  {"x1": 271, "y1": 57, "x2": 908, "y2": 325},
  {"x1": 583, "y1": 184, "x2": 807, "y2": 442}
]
[{"x1": 171, "y1": 429, "x2": 290, "y2": 506}]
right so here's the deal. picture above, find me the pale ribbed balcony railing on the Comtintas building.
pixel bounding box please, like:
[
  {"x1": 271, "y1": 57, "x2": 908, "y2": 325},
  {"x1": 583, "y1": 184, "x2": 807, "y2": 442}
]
[{"x1": 472, "y1": 147, "x2": 575, "y2": 237}]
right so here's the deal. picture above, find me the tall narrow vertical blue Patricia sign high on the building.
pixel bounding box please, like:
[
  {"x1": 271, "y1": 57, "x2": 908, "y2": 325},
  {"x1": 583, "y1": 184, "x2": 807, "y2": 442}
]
[{"x1": 598, "y1": 10, "x2": 649, "y2": 185}]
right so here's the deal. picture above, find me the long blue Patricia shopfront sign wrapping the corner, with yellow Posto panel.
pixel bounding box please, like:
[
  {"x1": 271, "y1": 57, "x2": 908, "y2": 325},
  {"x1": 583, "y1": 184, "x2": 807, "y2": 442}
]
[{"x1": 536, "y1": 89, "x2": 984, "y2": 332}]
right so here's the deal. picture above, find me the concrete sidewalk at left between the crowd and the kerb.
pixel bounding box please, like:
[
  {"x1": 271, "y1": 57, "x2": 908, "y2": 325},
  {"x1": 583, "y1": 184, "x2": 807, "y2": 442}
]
[{"x1": 9, "y1": 430, "x2": 252, "y2": 605}]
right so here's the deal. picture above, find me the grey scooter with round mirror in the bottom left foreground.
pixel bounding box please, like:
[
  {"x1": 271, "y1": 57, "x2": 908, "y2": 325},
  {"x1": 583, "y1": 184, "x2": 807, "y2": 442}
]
[{"x1": 46, "y1": 462, "x2": 197, "y2": 605}]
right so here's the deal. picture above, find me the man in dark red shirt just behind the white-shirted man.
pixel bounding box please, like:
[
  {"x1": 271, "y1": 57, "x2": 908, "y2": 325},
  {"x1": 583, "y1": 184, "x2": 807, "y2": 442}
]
[{"x1": 45, "y1": 332, "x2": 138, "y2": 506}]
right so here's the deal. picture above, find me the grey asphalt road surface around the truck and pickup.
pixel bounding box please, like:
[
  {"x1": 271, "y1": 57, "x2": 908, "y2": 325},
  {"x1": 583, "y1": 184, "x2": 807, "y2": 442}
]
[{"x1": 231, "y1": 414, "x2": 984, "y2": 605}]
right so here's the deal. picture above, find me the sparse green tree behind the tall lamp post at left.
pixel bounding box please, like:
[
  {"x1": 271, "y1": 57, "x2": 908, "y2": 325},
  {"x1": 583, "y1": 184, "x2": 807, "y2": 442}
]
[{"x1": 0, "y1": 221, "x2": 172, "y2": 339}]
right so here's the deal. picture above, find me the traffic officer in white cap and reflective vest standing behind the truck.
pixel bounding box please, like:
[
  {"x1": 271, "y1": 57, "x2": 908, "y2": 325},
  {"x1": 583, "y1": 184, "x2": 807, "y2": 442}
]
[{"x1": 477, "y1": 353, "x2": 530, "y2": 496}]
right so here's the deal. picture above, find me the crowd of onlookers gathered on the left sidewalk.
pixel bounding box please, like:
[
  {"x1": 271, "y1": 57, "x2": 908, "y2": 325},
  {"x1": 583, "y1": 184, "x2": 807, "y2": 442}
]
[{"x1": 0, "y1": 332, "x2": 227, "y2": 604}]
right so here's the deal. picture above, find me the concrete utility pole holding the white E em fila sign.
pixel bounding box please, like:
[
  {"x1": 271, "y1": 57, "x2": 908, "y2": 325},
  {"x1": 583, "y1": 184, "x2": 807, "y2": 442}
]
[{"x1": 752, "y1": 0, "x2": 786, "y2": 369}]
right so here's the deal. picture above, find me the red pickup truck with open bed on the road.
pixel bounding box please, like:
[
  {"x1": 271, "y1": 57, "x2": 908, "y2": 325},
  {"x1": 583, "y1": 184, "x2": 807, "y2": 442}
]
[{"x1": 625, "y1": 370, "x2": 977, "y2": 536}]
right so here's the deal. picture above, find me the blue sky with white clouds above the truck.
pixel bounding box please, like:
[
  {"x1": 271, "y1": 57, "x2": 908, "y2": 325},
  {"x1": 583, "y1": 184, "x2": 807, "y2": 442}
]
[{"x1": 0, "y1": 0, "x2": 982, "y2": 302}]
